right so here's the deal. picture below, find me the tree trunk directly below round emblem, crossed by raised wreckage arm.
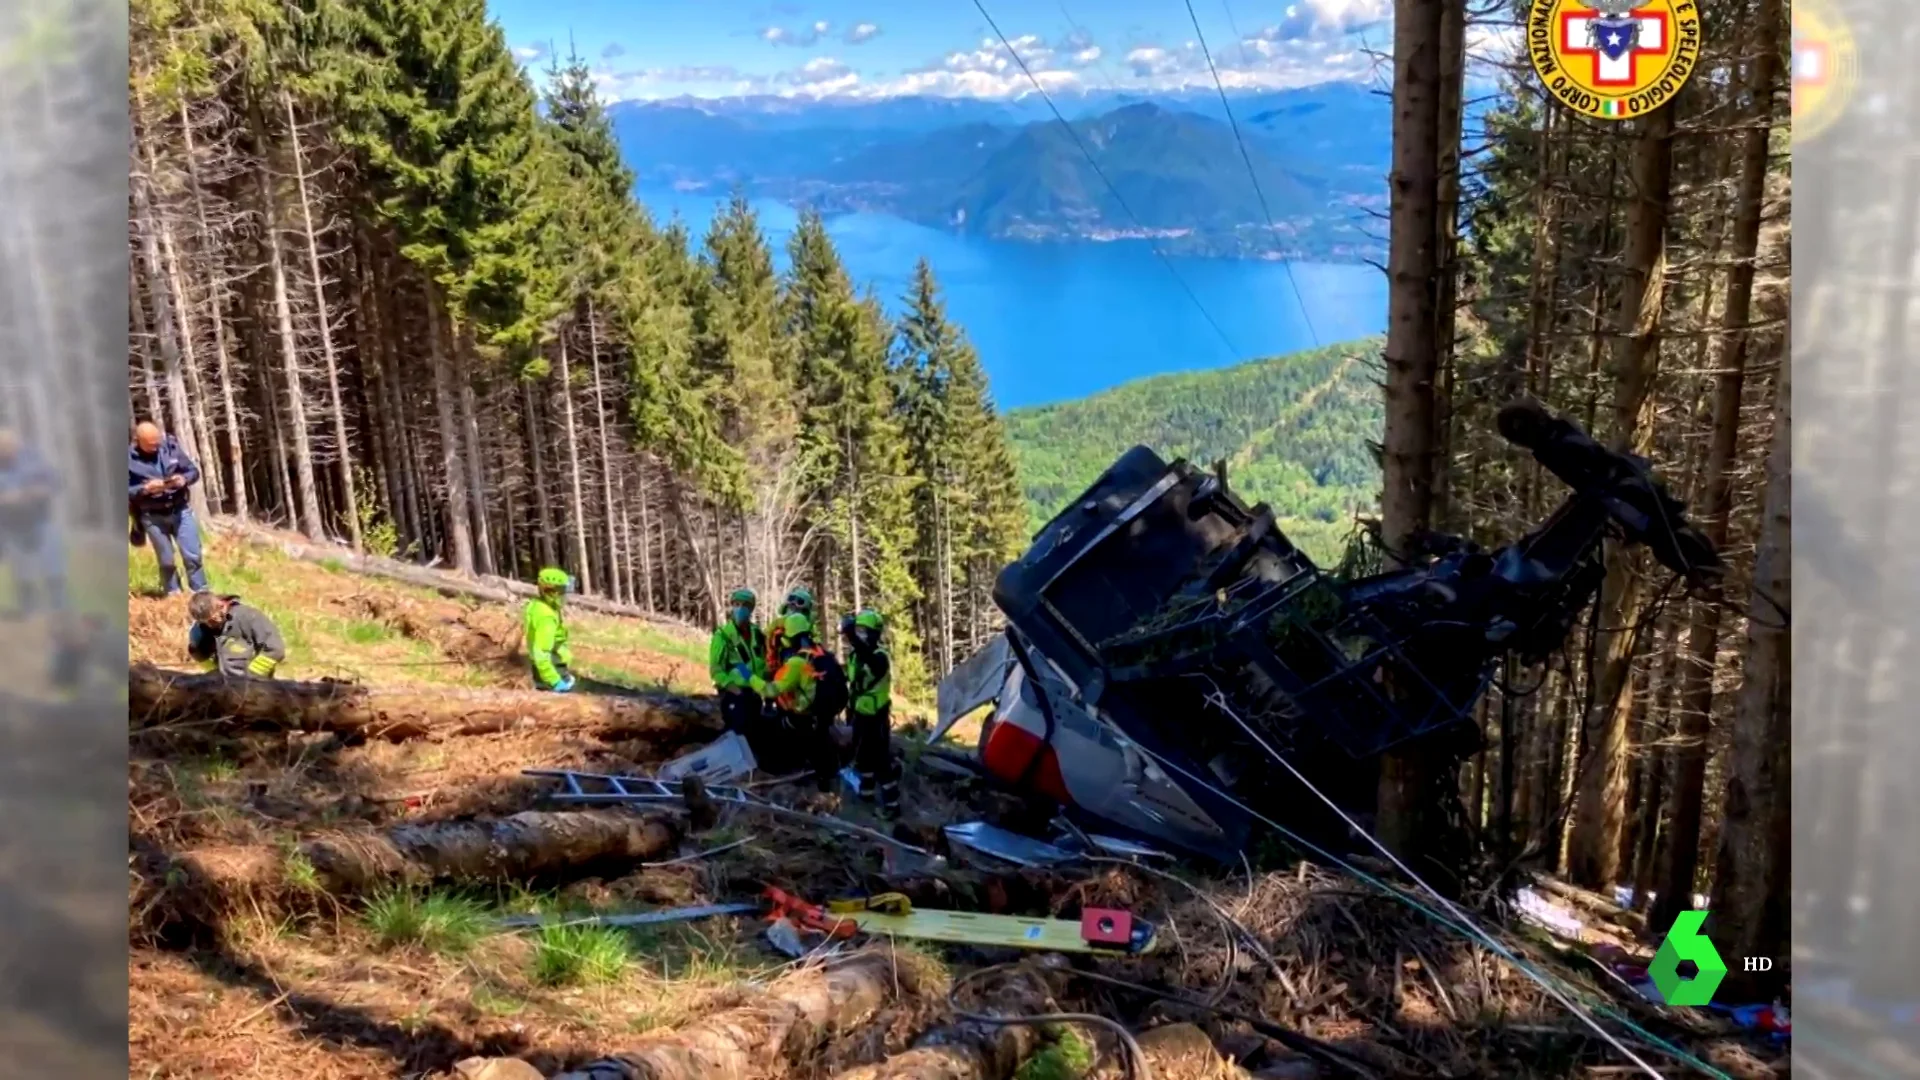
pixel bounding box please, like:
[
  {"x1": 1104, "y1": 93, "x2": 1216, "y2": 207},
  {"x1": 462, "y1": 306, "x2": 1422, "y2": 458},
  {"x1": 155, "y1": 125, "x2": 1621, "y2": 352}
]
[{"x1": 1567, "y1": 102, "x2": 1674, "y2": 888}]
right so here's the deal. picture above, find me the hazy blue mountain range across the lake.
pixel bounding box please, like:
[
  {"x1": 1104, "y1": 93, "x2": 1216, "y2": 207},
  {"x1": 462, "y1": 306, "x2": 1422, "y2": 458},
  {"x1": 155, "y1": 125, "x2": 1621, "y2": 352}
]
[{"x1": 612, "y1": 83, "x2": 1392, "y2": 261}]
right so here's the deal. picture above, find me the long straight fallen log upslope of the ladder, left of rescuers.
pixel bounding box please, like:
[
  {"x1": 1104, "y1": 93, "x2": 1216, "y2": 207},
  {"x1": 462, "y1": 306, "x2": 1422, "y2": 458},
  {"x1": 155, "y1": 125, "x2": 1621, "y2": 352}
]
[{"x1": 127, "y1": 663, "x2": 720, "y2": 742}]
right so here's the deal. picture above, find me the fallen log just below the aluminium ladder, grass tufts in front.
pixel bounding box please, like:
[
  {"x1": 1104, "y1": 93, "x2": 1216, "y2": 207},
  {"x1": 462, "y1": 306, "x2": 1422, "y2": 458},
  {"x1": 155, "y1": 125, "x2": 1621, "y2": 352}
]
[{"x1": 169, "y1": 809, "x2": 680, "y2": 917}]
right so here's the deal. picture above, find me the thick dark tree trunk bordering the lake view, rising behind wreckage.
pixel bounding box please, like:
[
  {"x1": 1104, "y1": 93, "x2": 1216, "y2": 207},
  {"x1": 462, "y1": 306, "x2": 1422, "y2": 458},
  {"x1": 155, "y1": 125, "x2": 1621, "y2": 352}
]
[{"x1": 1377, "y1": 0, "x2": 1448, "y2": 857}]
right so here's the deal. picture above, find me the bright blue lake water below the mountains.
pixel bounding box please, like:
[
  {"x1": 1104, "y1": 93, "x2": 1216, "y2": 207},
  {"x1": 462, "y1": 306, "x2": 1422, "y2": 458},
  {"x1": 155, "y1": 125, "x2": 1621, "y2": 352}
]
[{"x1": 639, "y1": 188, "x2": 1386, "y2": 409}]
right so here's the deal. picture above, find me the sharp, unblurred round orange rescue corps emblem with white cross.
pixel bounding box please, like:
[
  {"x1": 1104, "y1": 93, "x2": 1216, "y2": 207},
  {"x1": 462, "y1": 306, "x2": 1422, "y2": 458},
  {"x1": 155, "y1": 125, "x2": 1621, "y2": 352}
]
[{"x1": 1526, "y1": 0, "x2": 1699, "y2": 119}]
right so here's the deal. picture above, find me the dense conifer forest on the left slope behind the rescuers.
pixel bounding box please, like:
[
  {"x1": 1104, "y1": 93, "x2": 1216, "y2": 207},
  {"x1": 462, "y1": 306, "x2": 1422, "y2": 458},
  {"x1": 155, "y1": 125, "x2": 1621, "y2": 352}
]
[{"x1": 129, "y1": 0, "x2": 1021, "y2": 684}]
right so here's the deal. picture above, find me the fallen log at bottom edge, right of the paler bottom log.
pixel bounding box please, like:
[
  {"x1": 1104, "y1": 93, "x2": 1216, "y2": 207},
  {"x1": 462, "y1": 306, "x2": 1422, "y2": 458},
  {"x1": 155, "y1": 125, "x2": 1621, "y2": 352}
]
[{"x1": 835, "y1": 970, "x2": 1054, "y2": 1080}]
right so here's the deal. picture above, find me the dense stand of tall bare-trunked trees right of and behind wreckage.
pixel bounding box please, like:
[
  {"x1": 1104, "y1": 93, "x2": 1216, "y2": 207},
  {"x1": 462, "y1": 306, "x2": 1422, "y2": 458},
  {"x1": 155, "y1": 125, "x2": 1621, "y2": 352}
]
[{"x1": 1377, "y1": 0, "x2": 1797, "y2": 1001}]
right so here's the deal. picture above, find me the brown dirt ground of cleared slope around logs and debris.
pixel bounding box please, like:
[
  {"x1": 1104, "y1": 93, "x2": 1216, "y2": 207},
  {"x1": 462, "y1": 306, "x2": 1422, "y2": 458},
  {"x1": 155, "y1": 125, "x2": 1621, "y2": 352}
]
[{"x1": 129, "y1": 552, "x2": 1768, "y2": 1080}]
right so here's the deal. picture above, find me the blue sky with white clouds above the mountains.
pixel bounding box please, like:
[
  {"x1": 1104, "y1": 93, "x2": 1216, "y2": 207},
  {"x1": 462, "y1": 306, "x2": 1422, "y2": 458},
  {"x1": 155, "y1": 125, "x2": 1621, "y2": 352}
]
[{"x1": 490, "y1": 0, "x2": 1484, "y2": 100}]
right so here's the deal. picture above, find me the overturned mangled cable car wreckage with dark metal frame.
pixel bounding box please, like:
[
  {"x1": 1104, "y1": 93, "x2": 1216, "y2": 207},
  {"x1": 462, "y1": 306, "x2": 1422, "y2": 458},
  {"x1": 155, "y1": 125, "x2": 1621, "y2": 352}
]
[{"x1": 933, "y1": 402, "x2": 1720, "y2": 859}]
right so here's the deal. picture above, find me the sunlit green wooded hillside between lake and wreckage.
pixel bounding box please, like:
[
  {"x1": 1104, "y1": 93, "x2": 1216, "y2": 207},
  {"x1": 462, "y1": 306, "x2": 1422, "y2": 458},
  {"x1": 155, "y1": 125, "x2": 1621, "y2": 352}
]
[{"x1": 1006, "y1": 338, "x2": 1382, "y2": 565}]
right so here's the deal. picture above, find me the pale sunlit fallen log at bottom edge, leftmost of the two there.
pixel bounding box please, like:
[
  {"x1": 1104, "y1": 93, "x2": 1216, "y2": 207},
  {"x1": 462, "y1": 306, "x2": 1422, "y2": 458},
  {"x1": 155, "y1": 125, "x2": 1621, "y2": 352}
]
[{"x1": 553, "y1": 949, "x2": 914, "y2": 1080}]
